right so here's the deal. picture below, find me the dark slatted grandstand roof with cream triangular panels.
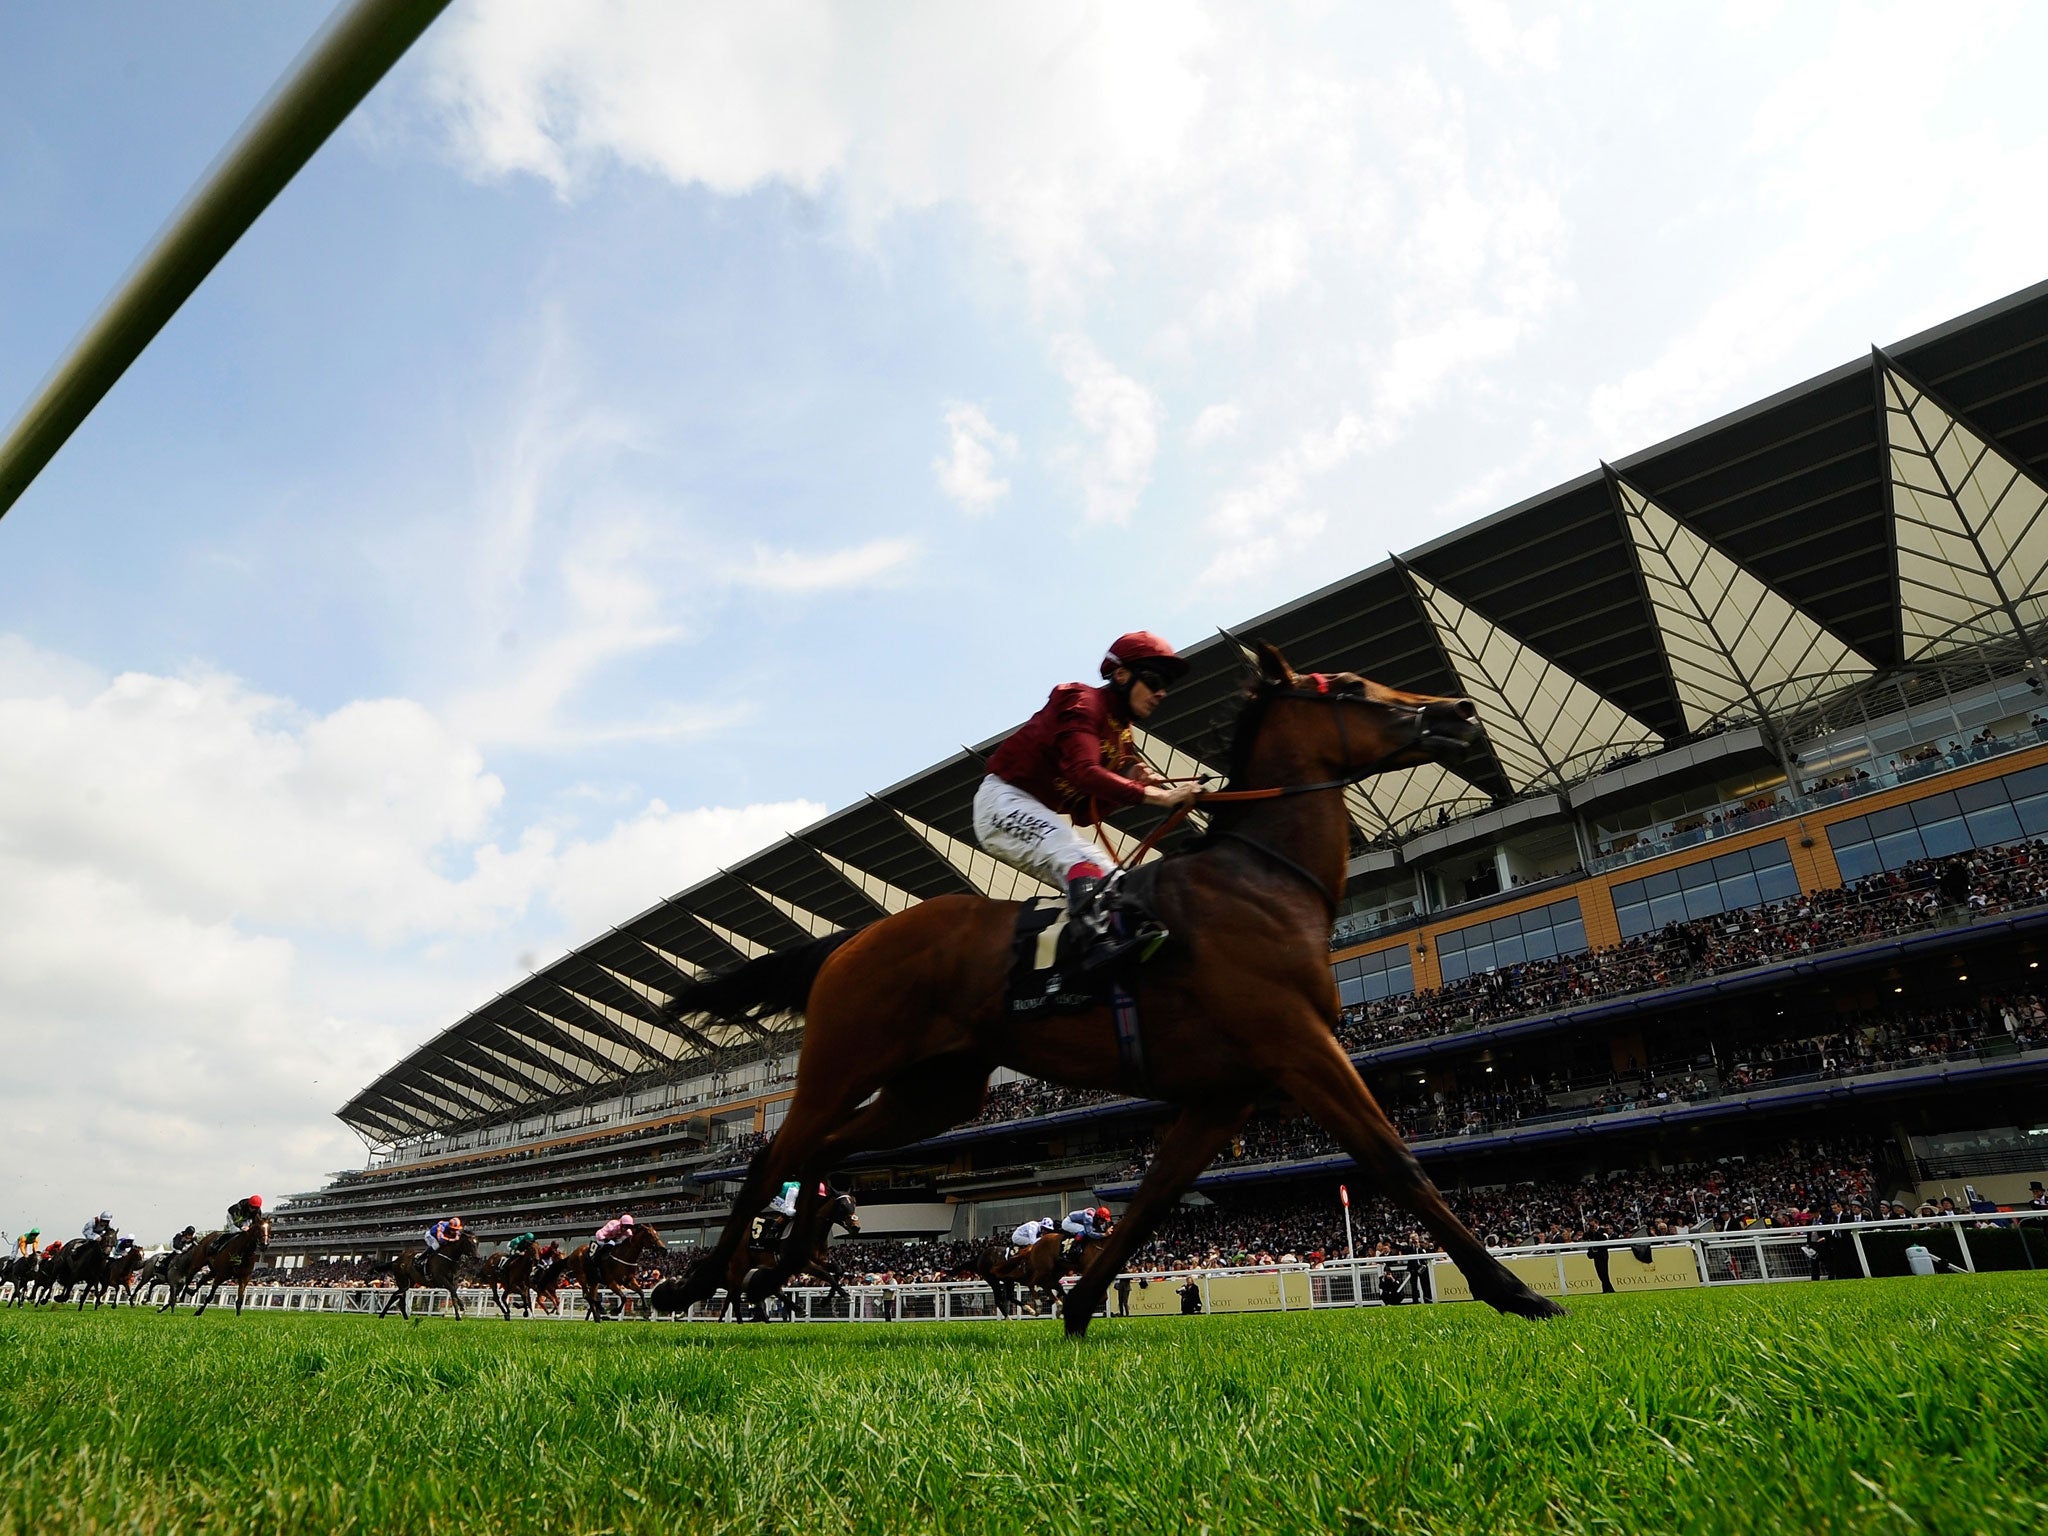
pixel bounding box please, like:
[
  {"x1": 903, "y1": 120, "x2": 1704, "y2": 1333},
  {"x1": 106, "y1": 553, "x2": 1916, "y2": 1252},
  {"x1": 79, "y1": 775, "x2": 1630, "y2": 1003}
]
[{"x1": 340, "y1": 283, "x2": 2048, "y2": 1145}]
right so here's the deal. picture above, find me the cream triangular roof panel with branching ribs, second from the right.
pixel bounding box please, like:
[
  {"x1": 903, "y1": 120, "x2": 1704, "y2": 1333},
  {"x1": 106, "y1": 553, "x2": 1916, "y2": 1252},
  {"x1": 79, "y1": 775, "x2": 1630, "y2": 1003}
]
[{"x1": 1608, "y1": 469, "x2": 1876, "y2": 731}]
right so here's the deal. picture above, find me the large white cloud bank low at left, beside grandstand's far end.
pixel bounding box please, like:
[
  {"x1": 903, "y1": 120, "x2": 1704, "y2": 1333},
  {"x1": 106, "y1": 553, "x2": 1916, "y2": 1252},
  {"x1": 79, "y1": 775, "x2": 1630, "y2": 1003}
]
[{"x1": 0, "y1": 637, "x2": 823, "y2": 1239}]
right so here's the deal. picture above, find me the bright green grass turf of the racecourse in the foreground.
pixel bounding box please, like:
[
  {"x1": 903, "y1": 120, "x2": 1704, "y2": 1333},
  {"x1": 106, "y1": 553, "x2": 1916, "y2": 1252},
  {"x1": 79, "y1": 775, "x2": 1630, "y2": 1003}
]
[{"x1": 0, "y1": 1274, "x2": 2048, "y2": 1536}]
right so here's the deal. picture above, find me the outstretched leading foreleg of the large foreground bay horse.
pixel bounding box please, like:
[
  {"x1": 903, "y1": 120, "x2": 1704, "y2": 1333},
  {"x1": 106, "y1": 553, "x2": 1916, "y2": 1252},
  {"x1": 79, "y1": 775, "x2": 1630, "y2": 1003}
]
[{"x1": 1270, "y1": 1018, "x2": 1565, "y2": 1317}]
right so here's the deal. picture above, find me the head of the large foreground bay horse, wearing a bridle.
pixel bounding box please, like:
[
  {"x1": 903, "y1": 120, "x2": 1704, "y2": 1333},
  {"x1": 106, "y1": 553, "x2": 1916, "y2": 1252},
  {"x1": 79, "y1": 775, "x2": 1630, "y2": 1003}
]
[{"x1": 1239, "y1": 641, "x2": 1483, "y2": 778}]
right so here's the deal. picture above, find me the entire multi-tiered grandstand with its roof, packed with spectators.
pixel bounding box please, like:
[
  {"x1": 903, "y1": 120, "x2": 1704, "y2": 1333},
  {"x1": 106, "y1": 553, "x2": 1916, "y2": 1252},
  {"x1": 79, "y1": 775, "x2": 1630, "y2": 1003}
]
[{"x1": 274, "y1": 285, "x2": 2048, "y2": 1266}]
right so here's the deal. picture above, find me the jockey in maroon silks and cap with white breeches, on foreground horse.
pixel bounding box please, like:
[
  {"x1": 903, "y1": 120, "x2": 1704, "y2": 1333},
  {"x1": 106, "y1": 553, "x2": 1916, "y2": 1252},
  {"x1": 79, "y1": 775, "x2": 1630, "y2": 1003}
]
[{"x1": 975, "y1": 629, "x2": 1198, "y2": 969}]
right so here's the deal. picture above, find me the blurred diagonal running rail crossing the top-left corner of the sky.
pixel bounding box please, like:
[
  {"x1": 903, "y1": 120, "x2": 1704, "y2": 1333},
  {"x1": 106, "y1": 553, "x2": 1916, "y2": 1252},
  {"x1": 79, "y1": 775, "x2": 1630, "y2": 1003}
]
[{"x1": 0, "y1": 0, "x2": 449, "y2": 516}]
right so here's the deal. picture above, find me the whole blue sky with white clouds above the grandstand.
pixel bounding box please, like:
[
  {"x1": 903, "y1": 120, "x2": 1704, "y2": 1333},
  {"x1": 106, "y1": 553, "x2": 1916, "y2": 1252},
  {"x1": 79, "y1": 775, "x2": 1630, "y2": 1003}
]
[{"x1": 0, "y1": 0, "x2": 2048, "y2": 1231}]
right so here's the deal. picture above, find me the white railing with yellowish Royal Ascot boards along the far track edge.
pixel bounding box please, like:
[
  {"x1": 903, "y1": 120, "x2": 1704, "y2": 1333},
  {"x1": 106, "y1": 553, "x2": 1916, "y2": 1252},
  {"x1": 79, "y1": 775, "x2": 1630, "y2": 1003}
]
[{"x1": 79, "y1": 1210, "x2": 2048, "y2": 1323}]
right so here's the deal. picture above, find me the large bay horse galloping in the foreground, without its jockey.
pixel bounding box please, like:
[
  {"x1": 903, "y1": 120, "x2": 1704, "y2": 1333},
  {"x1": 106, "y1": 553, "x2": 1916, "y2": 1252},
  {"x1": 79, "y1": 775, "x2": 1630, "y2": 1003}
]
[{"x1": 670, "y1": 643, "x2": 1563, "y2": 1335}]
